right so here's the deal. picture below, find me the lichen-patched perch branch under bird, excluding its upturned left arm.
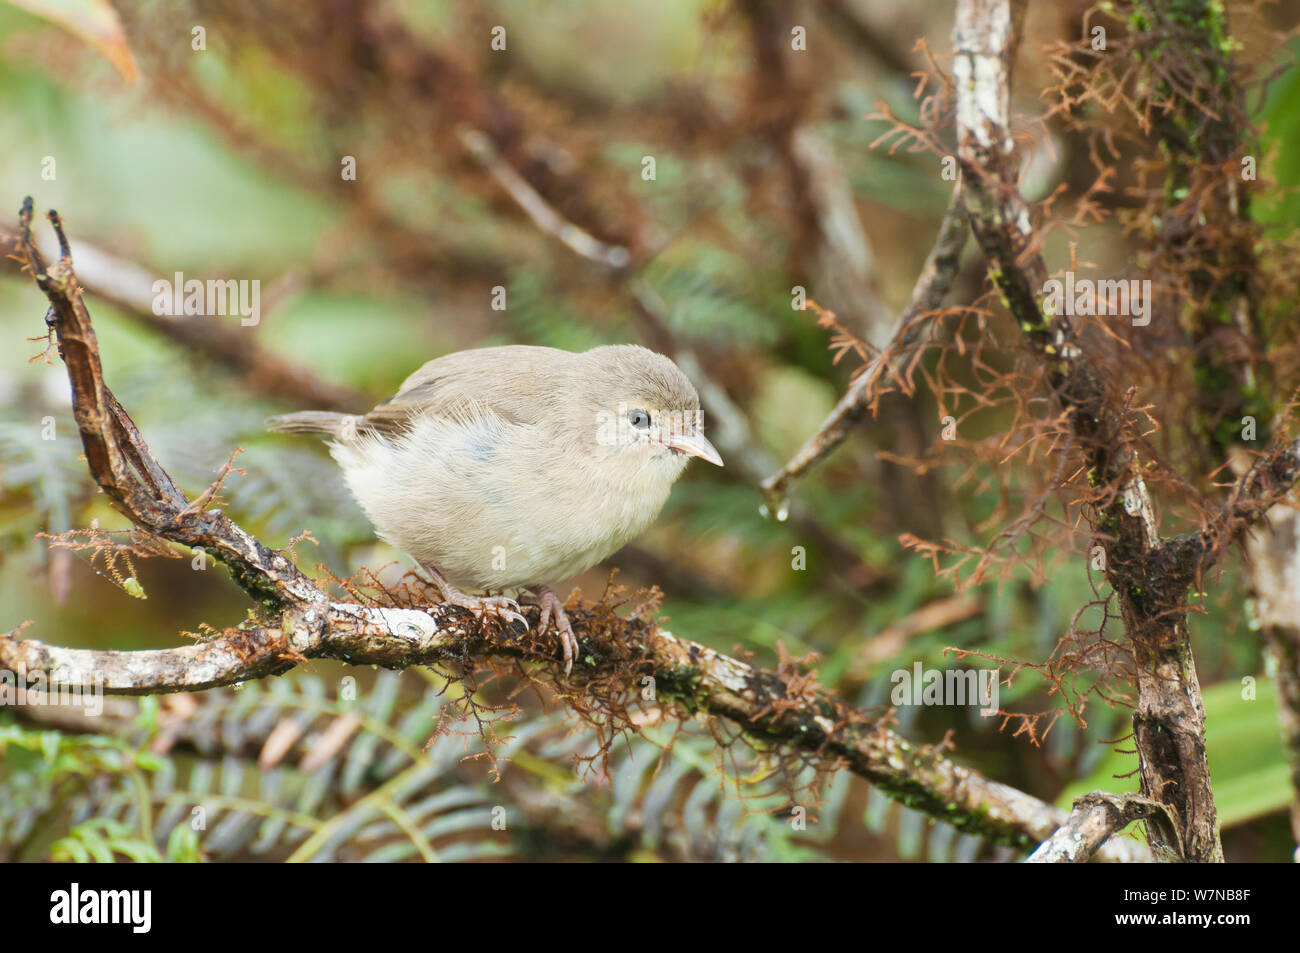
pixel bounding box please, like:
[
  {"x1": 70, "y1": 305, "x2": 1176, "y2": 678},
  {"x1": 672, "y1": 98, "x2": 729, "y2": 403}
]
[{"x1": 0, "y1": 613, "x2": 1147, "y2": 862}]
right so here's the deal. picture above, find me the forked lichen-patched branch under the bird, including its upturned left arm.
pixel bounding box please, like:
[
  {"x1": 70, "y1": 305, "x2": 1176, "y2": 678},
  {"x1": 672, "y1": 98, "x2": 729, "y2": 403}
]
[{"x1": 10, "y1": 199, "x2": 1135, "y2": 859}]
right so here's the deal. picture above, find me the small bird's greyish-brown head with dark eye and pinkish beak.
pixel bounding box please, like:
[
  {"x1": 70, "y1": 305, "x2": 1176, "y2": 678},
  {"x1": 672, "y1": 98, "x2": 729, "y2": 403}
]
[{"x1": 576, "y1": 345, "x2": 723, "y2": 476}]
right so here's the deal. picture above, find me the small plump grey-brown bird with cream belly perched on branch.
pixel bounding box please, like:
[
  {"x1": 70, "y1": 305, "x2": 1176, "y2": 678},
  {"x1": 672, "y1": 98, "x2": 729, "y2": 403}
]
[{"x1": 267, "y1": 345, "x2": 724, "y2": 676}]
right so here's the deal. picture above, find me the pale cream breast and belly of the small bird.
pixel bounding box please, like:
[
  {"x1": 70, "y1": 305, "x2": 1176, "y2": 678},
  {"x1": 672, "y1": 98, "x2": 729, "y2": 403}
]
[{"x1": 334, "y1": 415, "x2": 681, "y2": 590}]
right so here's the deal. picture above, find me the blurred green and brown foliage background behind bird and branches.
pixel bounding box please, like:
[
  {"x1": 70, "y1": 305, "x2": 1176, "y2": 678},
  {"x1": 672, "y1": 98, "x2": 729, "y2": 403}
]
[{"x1": 0, "y1": 0, "x2": 1300, "y2": 861}]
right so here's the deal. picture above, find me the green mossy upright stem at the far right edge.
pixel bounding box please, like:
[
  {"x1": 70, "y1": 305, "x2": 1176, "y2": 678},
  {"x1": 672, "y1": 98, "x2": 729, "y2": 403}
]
[{"x1": 1133, "y1": 0, "x2": 1300, "y2": 844}]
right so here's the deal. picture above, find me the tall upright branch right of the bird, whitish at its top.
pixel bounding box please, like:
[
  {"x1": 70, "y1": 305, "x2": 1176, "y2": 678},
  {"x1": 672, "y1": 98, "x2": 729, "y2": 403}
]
[{"x1": 953, "y1": 0, "x2": 1223, "y2": 862}]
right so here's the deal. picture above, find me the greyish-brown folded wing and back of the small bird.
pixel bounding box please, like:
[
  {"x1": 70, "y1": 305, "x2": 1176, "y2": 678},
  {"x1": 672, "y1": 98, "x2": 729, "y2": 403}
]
[{"x1": 358, "y1": 345, "x2": 572, "y2": 434}]
